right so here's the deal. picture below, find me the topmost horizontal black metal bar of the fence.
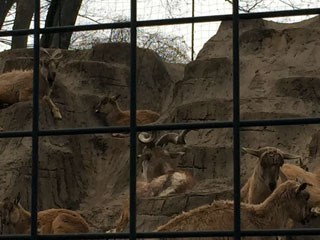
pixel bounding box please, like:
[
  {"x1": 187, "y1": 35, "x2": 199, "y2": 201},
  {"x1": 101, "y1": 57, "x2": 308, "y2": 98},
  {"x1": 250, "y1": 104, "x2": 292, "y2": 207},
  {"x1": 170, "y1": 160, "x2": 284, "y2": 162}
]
[{"x1": 0, "y1": 8, "x2": 320, "y2": 37}]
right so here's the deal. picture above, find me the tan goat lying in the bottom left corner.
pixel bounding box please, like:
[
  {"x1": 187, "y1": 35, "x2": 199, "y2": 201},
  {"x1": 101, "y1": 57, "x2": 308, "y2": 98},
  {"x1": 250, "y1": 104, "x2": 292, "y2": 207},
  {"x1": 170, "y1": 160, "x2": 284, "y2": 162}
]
[{"x1": 0, "y1": 194, "x2": 89, "y2": 234}]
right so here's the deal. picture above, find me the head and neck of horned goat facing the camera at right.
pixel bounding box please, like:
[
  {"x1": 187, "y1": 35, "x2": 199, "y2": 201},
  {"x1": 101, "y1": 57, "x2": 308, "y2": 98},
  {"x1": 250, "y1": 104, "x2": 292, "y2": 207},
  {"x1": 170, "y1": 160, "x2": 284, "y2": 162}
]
[{"x1": 241, "y1": 147, "x2": 300, "y2": 204}]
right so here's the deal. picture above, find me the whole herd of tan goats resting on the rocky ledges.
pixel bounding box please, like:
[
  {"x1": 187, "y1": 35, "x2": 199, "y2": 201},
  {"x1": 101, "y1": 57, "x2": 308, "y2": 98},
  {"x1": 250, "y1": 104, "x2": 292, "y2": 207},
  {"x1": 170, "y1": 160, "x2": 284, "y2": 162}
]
[{"x1": 0, "y1": 49, "x2": 320, "y2": 239}]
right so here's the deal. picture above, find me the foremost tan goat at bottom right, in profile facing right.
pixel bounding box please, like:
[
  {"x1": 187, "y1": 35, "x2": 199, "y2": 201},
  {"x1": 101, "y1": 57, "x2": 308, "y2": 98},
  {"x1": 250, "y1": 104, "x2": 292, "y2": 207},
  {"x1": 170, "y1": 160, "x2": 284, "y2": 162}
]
[{"x1": 156, "y1": 180, "x2": 311, "y2": 240}]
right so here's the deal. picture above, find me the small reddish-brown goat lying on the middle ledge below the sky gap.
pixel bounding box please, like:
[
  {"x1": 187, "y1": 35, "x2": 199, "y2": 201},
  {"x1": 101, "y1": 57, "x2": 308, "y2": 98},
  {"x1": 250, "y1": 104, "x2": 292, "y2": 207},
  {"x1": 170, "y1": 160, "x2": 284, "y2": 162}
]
[{"x1": 95, "y1": 94, "x2": 160, "y2": 137}]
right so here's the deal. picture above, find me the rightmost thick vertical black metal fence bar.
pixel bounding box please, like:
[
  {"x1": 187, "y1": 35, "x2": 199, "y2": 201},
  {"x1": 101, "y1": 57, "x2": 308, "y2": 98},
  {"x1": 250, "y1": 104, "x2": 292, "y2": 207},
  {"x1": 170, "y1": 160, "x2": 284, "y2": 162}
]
[{"x1": 232, "y1": 0, "x2": 241, "y2": 240}]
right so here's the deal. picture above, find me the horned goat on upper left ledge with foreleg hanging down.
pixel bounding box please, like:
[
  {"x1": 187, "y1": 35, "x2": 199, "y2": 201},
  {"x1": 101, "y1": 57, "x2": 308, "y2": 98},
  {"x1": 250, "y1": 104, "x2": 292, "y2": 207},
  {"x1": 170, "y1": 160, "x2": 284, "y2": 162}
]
[{"x1": 0, "y1": 48, "x2": 62, "y2": 119}]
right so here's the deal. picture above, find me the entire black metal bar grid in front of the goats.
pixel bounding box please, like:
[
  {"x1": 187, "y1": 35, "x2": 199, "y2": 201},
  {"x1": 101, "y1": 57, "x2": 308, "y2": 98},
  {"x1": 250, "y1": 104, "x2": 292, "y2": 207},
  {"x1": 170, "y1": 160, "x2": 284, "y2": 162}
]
[{"x1": 0, "y1": 0, "x2": 320, "y2": 239}]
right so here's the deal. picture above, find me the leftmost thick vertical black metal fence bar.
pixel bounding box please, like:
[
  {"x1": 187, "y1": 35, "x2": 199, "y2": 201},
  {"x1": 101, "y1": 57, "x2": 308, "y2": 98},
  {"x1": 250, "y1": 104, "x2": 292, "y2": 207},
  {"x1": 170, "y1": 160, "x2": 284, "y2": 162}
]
[{"x1": 31, "y1": 0, "x2": 40, "y2": 240}]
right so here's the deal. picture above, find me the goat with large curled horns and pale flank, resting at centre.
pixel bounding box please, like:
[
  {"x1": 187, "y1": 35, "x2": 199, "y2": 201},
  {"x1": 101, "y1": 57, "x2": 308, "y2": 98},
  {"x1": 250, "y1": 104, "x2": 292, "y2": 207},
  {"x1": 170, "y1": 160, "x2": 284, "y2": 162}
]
[{"x1": 108, "y1": 130, "x2": 194, "y2": 232}]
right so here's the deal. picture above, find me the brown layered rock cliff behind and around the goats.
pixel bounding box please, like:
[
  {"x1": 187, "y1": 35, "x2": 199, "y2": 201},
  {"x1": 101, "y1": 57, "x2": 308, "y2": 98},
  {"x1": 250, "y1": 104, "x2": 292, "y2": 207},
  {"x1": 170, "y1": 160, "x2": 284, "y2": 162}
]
[{"x1": 0, "y1": 17, "x2": 320, "y2": 239}]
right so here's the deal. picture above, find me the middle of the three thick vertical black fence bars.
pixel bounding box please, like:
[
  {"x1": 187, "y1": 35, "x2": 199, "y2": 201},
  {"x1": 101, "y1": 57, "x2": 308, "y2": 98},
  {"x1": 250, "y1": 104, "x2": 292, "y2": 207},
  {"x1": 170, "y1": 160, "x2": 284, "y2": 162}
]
[{"x1": 130, "y1": 0, "x2": 137, "y2": 240}]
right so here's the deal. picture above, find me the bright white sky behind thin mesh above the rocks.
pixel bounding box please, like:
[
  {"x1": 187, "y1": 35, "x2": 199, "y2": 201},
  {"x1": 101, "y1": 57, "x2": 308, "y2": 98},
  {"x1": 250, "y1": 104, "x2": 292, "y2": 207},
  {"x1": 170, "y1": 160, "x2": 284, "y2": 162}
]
[{"x1": 0, "y1": 0, "x2": 320, "y2": 63}]
